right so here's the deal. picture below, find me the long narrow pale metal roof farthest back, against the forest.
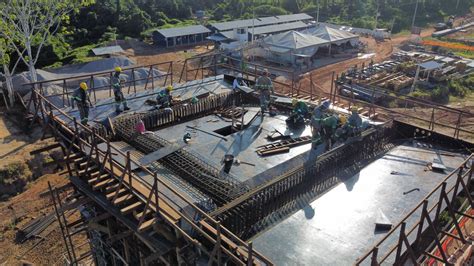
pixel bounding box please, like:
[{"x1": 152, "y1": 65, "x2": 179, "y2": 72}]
[{"x1": 211, "y1": 13, "x2": 313, "y2": 31}]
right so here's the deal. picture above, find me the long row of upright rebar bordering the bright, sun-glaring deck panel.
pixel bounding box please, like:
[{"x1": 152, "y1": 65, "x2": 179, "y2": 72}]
[{"x1": 211, "y1": 126, "x2": 393, "y2": 239}]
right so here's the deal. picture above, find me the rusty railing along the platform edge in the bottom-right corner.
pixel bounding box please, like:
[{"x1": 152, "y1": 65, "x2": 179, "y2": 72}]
[{"x1": 356, "y1": 154, "x2": 474, "y2": 265}]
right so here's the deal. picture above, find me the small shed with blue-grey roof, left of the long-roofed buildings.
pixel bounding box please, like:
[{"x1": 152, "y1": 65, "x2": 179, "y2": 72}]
[{"x1": 153, "y1": 25, "x2": 211, "y2": 47}]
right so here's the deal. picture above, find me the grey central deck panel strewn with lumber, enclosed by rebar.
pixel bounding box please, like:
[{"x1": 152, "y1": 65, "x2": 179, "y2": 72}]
[{"x1": 156, "y1": 111, "x2": 311, "y2": 182}]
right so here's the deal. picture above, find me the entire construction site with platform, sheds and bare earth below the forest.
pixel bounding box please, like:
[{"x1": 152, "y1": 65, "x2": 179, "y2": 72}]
[{"x1": 0, "y1": 6, "x2": 474, "y2": 266}]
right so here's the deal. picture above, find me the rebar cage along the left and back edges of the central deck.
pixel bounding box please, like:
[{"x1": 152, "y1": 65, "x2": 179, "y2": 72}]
[{"x1": 114, "y1": 93, "x2": 246, "y2": 206}]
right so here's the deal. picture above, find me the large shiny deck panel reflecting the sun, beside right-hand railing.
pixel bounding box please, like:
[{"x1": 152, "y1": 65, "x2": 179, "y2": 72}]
[{"x1": 253, "y1": 143, "x2": 465, "y2": 265}]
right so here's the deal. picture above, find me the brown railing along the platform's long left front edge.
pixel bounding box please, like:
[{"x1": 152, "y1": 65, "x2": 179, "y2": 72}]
[{"x1": 31, "y1": 90, "x2": 273, "y2": 265}]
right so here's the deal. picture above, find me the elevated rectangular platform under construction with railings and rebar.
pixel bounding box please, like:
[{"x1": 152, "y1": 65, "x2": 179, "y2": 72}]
[{"x1": 24, "y1": 54, "x2": 474, "y2": 265}]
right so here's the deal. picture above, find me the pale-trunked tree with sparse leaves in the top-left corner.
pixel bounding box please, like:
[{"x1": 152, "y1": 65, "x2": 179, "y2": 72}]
[{"x1": 0, "y1": 0, "x2": 92, "y2": 82}]
